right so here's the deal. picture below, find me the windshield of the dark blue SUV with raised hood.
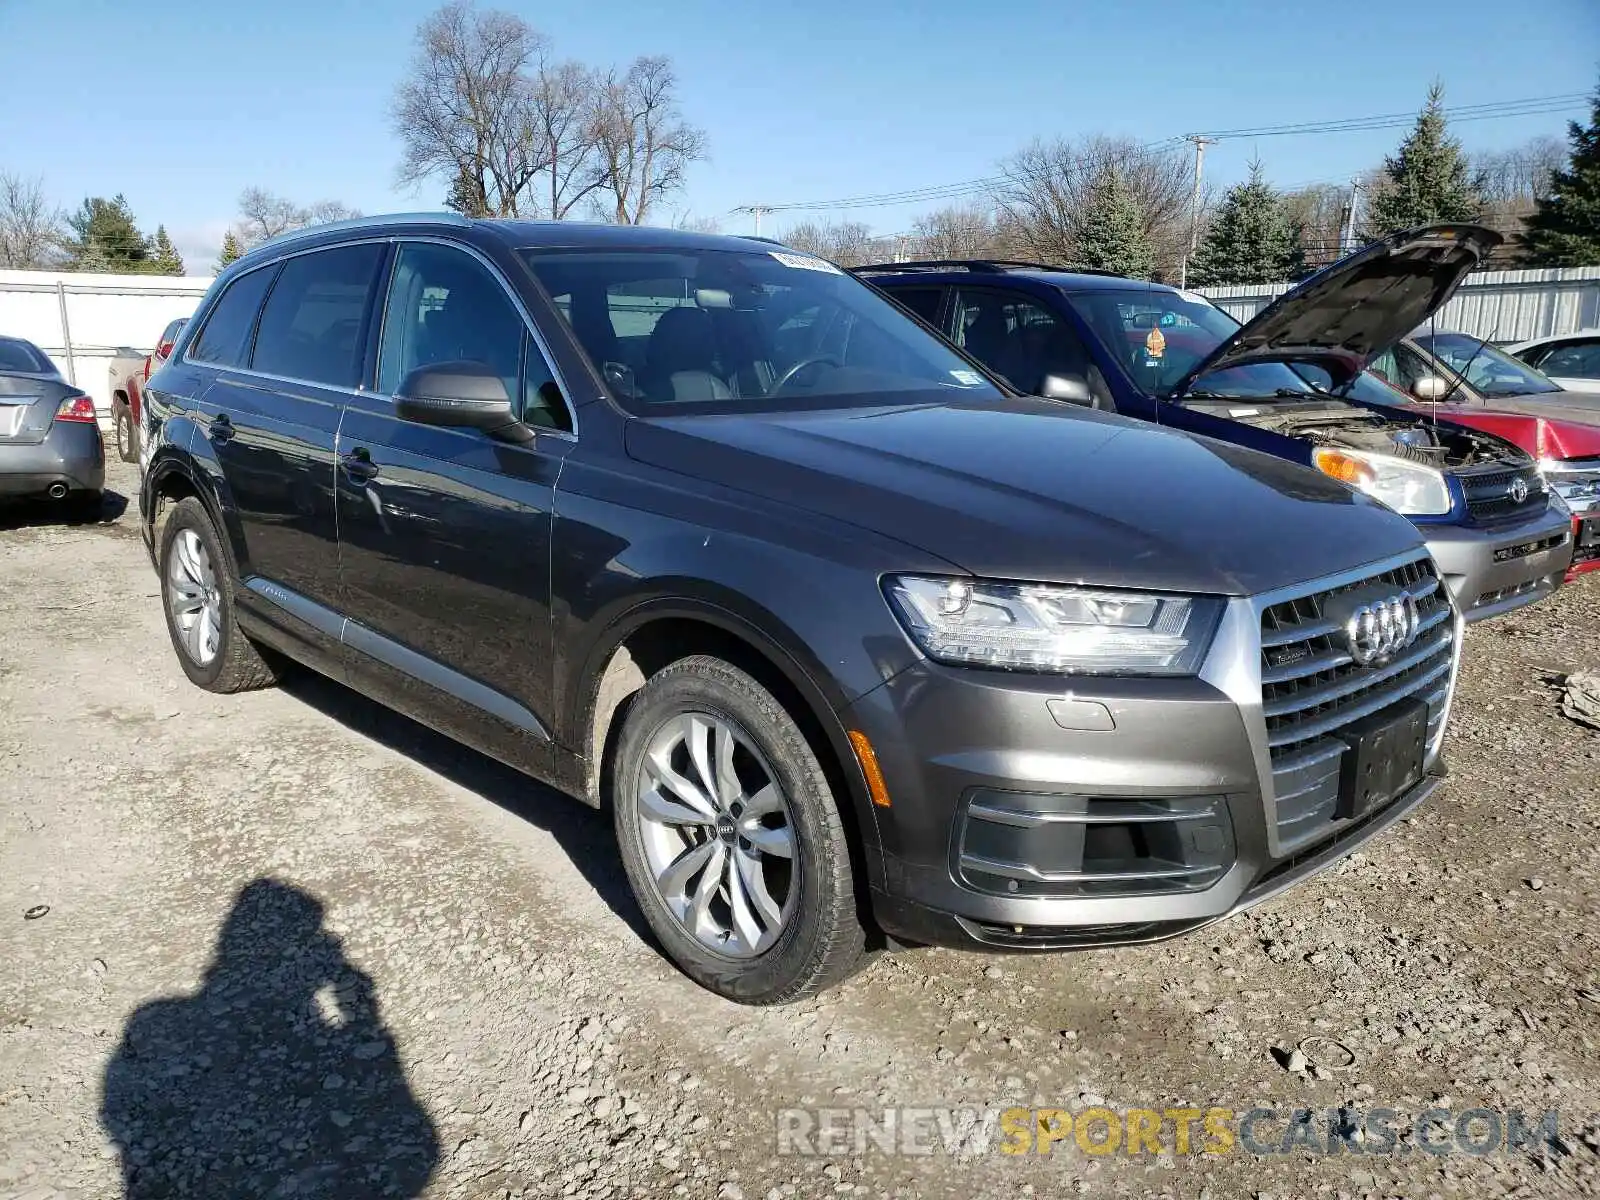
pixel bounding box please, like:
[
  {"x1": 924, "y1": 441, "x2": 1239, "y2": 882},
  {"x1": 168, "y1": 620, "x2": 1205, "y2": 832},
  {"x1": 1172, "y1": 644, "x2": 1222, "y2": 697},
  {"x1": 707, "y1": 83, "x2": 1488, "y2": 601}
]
[{"x1": 1067, "y1": 288, "x2": 1310, "y2": 400}]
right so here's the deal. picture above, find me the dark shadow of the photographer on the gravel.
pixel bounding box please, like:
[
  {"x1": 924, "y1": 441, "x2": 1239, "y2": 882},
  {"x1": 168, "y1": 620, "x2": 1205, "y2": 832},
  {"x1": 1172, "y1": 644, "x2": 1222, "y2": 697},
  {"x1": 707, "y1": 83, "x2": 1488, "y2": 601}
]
[{"x1": 101, "y1": 878, "x2": 438, "y2": 1200}]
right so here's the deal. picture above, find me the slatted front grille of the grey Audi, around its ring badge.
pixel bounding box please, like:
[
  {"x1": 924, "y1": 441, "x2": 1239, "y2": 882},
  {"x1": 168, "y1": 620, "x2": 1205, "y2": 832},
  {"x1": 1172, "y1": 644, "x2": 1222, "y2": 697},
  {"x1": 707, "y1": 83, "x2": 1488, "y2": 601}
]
[{"x1": 1261, "y1": 558, "x2": 1456, "y2": 848}]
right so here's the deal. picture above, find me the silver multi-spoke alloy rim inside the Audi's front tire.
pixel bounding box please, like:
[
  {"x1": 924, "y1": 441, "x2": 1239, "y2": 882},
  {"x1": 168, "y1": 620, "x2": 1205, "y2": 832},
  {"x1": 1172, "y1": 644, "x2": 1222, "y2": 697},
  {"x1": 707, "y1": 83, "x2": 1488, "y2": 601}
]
[{"x1": 635, "y1": 712, "x2": 800, "y2": 958}]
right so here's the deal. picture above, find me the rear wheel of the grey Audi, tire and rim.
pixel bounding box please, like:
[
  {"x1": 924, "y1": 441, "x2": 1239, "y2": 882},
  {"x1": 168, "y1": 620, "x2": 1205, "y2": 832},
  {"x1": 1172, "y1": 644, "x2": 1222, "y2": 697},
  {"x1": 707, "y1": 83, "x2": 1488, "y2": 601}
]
[{"x1": 157, "y1": 496, "x2": 278, "y2": 693}]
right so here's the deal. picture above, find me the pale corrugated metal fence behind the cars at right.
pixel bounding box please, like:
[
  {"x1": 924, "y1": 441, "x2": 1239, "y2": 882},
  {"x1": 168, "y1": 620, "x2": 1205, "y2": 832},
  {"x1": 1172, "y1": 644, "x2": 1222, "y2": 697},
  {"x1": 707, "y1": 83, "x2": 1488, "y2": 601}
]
[{"x1": 1197, "y1": 267, "x2": 1600, "y2": 342}]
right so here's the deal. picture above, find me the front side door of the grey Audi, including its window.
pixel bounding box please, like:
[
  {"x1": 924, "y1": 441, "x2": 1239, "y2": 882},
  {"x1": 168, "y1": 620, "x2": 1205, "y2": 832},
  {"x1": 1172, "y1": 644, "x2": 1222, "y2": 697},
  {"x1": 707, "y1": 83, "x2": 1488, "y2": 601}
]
[{"x1": 338, "y1": 242, "x2": 573, "y2": 771}]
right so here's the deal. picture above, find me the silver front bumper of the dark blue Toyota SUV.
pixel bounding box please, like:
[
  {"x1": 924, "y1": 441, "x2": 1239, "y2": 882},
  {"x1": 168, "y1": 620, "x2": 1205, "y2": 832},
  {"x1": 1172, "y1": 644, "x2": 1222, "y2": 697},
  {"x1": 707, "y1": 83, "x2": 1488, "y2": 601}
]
[{"x1": 1422, "y1": 504, "x2": 1573, "y2": 622}]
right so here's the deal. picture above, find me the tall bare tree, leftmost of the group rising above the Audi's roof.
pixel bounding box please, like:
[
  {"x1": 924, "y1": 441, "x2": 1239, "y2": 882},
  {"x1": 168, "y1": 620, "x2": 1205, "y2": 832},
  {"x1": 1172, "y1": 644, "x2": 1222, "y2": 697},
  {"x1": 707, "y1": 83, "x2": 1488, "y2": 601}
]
[{"x1": 392, "y1": 0, "x2": 549, "y2": 216}]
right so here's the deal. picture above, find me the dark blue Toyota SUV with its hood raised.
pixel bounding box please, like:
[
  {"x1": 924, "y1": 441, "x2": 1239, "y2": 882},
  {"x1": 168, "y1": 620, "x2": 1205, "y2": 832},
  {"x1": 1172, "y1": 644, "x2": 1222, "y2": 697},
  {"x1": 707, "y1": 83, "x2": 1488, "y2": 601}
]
[{"x1": 856, "y1": 226, "x2": 1573, "y2": 621}]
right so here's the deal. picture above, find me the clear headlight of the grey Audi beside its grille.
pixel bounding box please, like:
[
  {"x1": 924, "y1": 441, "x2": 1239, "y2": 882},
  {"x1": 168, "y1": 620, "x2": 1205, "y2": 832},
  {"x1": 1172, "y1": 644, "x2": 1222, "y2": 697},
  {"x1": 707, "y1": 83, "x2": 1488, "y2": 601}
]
[{"x1": 885, "y1": 574, "x2": 1222, "y2": 675}]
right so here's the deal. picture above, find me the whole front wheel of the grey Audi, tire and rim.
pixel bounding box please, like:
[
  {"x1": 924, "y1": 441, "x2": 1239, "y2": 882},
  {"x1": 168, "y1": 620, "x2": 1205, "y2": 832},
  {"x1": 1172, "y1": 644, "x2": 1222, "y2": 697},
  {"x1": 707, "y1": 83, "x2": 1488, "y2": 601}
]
[{"x1": 611, "y1": 656, "x2": 864, "y2": 1005}]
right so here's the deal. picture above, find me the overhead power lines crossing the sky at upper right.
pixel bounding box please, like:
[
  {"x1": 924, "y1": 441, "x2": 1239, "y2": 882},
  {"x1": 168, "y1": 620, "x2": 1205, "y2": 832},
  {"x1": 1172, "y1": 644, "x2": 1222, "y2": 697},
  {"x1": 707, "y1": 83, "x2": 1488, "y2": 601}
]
[{"x1": 733, "y1": 93, "x2": 1589, "y2": 213}]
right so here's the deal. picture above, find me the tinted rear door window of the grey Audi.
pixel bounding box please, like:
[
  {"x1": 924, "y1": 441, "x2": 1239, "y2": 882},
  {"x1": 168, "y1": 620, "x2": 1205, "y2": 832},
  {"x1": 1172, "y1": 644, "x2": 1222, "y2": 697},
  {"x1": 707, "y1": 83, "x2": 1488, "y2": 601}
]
[{"x1": 250, "y1": 243, "x2": 384, "y2": 387}]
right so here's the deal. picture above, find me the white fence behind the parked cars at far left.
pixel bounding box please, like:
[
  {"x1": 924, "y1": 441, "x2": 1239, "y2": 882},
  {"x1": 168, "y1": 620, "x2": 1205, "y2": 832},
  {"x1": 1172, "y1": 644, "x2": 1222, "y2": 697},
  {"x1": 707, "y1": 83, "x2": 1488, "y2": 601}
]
[{"x1": 0, "y1": 270, "x2": 211, "y2": 418}]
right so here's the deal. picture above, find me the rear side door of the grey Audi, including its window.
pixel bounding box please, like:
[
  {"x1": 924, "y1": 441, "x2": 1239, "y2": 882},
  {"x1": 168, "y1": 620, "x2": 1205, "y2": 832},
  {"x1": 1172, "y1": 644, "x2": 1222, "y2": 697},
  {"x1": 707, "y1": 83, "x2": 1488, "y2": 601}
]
[{"x1": 197, "y1": 242, "x2": 387, "y2": 666}]
